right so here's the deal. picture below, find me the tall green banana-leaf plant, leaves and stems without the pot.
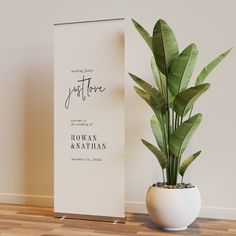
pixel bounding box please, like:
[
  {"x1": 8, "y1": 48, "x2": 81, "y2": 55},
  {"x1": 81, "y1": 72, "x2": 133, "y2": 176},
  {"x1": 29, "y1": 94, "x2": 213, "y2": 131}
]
[{"x1": 129, "y1": 19, "x2": 231, "y2": 185}]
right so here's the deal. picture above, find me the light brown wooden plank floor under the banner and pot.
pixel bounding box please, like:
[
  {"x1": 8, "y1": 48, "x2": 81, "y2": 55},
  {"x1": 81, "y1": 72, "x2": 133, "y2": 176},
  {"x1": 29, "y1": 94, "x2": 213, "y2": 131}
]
[{"x1": 0, "y1": 204, "x2": 236, "y2": 236}]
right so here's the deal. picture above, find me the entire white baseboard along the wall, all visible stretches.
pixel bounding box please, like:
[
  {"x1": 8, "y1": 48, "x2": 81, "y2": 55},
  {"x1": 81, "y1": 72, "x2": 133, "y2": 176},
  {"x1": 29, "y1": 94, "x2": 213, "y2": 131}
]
[{"x1": 0, "y1": 193, "x2": 236, "y2": 220}]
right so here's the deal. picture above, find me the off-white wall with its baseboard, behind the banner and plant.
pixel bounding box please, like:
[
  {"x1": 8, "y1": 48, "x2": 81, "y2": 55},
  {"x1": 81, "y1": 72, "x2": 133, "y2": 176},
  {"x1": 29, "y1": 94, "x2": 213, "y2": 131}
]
[{"x1": 0, "y1": 0, "x2": 236, "y2": 219}]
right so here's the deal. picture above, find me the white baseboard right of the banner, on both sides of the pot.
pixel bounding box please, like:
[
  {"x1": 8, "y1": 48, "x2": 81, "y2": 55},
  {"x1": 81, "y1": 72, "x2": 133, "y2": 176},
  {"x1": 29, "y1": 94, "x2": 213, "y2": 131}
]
[{"x1": 125, "y1": 201, "x2": 236, "y2": 220}]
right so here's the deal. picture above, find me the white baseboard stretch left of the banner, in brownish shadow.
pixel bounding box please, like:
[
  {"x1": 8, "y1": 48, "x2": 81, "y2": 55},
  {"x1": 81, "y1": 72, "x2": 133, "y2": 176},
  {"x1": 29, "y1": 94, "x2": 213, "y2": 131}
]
[{"x1": 0, "y1": 193, "x2": 53, "y2": 207}]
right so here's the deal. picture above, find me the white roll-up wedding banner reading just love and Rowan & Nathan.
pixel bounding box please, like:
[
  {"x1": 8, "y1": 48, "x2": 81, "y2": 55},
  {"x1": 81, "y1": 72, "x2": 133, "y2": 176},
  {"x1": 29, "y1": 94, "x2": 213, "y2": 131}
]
[{"x1": 54, "y1": 18, "x2": 125, "y2": 221}]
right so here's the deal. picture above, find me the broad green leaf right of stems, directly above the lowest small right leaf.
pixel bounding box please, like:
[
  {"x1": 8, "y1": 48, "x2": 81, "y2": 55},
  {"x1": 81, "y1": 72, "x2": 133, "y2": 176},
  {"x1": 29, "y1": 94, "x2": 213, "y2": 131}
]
[{"x1": 170, "y1": 113, "x2": 202, "y2": 158}]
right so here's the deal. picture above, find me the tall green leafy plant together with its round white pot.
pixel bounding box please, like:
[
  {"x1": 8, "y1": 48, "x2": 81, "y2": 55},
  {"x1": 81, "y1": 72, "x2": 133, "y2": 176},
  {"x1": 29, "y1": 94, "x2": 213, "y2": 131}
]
[{"x1": 130, "y1": 19, "x2": 230, "y2": 230}]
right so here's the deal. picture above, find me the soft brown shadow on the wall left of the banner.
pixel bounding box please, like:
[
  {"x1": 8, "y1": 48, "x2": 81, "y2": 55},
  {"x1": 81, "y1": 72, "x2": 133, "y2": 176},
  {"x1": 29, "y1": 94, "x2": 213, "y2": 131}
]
[{"x1": 24, "y1": 47, "x2": 53, "y2": 205}]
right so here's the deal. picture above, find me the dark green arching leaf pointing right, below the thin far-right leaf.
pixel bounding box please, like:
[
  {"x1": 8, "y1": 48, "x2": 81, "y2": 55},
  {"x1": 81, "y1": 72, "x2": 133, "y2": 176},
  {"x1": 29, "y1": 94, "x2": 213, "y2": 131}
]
[{"x1": 174, "y1": 84, "x2": 210, "y2": 117}]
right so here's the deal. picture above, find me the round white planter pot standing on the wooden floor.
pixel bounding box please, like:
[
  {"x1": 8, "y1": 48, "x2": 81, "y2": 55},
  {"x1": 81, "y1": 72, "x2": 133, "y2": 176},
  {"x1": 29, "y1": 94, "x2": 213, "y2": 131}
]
[{"x1": 146, "y1": 187, "x2": 201, "y2": 231}]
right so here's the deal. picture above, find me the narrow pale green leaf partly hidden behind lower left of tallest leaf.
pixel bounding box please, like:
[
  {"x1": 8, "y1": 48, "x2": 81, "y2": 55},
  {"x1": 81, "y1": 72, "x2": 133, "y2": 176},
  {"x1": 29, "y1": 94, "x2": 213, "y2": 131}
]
[{"x1": 151, "y1": 56, "x2": 166, "y2": 96}]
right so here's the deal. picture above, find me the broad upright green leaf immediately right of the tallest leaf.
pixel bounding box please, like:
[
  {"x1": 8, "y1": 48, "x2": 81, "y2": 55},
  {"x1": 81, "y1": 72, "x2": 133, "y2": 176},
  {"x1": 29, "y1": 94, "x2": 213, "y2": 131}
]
[{"x1": 168, "y1": 44, "x2": 198, "y2": 96}]
